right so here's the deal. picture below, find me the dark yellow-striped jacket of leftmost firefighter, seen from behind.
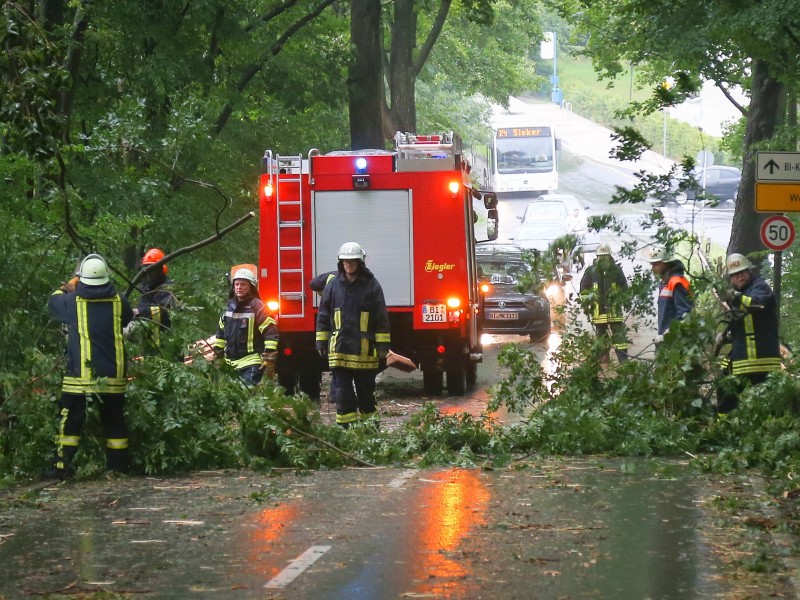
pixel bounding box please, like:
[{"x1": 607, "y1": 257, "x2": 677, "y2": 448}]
[{"x1": 48, "y1": 282, "x2": 133, "y2": 394}]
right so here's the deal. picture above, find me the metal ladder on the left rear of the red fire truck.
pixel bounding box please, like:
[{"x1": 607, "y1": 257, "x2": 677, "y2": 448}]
[{"x1": 275, "y1": 155, "x2": 307, "y2": 319}]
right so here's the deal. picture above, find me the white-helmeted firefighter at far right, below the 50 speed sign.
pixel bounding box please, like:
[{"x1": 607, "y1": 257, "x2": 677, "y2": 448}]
[{"x1": 717, "y1": 254, "x2": 781, "y2": 413}]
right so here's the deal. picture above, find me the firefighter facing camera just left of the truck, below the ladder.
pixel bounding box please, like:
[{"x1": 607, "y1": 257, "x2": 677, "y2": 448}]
[{"x1": 214, "y1": 265, "x2": 278, "y2": 386}]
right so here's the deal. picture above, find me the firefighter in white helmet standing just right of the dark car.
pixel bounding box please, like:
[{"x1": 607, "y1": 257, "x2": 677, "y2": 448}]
[{"x1": 580, "y1": 243, "x2": 628, "y2": 363}]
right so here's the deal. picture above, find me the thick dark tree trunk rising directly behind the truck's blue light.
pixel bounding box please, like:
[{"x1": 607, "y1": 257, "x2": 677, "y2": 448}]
[{"x1": 347, "y1": 0, "x2": 384, "y2": 150}]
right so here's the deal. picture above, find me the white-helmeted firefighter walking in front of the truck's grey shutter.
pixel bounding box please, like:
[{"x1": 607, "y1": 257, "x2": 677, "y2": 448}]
[{"x1": 316, "y1": 242, "x2": 390, "y2": 427}]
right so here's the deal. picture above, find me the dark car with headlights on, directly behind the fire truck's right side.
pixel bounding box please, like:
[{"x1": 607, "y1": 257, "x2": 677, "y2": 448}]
[{"x1": 476, "y1": 244, "x2": 551, "y2": 342}]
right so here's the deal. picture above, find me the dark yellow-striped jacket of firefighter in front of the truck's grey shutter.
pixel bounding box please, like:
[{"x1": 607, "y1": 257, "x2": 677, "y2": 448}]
[{"x1": 316, "y1": 265, "x2": 391, "y2": 369}]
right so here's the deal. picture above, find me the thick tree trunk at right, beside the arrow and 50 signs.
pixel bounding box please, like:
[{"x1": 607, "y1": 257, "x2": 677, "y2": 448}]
[{"x1": 728, "y1": 61, "x2": 783, "y2": 254}]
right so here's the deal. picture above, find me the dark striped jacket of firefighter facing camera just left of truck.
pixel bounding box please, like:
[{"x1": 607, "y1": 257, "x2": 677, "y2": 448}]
[{"x1": 214, "y1": 297, "x2": 278, "y2": 369}]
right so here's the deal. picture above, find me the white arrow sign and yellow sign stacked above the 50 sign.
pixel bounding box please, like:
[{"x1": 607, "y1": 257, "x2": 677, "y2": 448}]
[{"x1": 756, "y1": 152, "x2": 800, "y2": 212}]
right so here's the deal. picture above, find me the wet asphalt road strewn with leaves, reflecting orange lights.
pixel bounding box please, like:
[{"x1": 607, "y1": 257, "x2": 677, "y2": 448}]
[{"x1": 0, "y1": 338, "x2": 793, "y2": 600}]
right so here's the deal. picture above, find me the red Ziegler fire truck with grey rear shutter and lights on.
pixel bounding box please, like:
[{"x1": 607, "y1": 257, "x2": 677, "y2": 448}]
[{"x1": 259, "y1": 133, "x2": 498, "y2": 396}]
